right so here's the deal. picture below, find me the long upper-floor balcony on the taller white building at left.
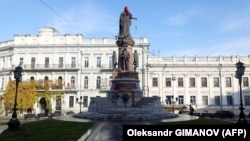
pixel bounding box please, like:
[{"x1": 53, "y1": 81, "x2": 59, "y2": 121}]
[{"x1": 23, "y1": 64, "x2": 80, "y2": 70}]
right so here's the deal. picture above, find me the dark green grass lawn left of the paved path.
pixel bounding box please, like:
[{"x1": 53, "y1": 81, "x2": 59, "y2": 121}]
[{"x1": 0, "y1": 119, "x2": 95, "y2": 141}]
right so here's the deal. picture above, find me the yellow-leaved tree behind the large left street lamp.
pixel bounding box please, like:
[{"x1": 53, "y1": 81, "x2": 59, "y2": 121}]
[{"x1": 4, "y1": 80, "x2": 37, "y2": 112}]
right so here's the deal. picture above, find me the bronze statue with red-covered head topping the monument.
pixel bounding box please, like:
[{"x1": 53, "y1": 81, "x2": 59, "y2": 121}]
[{"x1": 119, "y1": 6, "x2": 137, "y2": 38}]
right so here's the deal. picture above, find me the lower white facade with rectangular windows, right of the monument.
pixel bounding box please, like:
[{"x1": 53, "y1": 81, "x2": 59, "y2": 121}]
[{"x1": 147, "y1": 56, "x2": 250, "y2": 111}]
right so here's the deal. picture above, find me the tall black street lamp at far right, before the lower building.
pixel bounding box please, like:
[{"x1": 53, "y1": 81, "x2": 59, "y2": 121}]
[{"x1": 235, "y1": 61, "x2": 247, "y2": 124}]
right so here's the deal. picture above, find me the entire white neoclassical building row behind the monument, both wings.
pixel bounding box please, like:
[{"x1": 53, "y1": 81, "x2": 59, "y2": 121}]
[{"x1": 0, "y1": 27, "x2": 250, "y2": 115}]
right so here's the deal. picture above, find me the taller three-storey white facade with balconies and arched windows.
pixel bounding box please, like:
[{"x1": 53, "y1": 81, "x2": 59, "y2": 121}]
[{"x1": 0, "y1": 27, "x2": 149, "y2": 113}]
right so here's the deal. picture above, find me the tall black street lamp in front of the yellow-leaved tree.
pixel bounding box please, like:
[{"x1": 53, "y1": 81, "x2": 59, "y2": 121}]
[{"x1": 7, "y1": 66, "x2": 22, "y2": 130}]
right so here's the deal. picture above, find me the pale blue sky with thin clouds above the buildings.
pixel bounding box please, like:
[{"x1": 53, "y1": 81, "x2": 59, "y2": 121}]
[{"x1": 0, "y1": 0, "x2": 250, "y2": 57}]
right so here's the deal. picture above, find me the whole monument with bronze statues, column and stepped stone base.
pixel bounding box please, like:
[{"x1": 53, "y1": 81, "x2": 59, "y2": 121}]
[{"x1": 74, "y1": 6, "x2": 177, "y2": 120}]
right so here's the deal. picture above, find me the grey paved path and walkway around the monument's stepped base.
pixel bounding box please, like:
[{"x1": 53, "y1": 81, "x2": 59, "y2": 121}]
[{"x1": 0, "y1": 114, "x2": 197, "y2": 141}]
